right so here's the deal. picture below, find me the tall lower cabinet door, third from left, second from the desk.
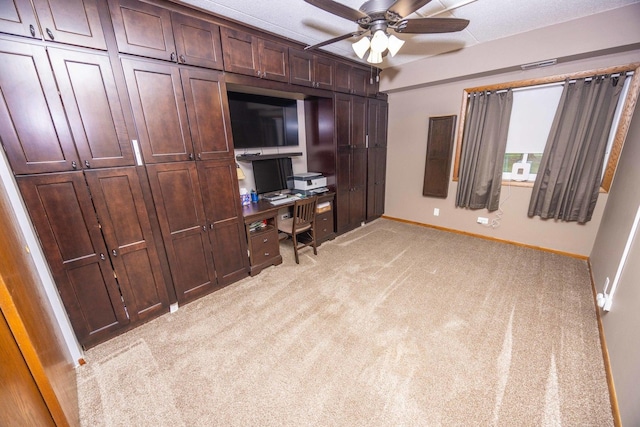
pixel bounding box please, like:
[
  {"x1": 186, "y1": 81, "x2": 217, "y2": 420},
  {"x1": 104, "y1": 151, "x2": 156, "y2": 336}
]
[{"x1": 147, "y1": 162, "x2": 217, "y2": 303}]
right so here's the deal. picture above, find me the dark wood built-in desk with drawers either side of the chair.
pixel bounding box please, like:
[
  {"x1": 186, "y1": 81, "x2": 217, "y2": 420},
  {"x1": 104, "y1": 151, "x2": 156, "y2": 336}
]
[{"x1": 242, "y1": 192, "x2": 336, "y2": 276}]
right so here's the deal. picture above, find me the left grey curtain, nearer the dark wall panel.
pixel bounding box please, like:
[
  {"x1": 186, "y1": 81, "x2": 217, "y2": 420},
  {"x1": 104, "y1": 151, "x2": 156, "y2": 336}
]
[{"x1": 456, "y1": 89, "x2": 513, "y2": 211}]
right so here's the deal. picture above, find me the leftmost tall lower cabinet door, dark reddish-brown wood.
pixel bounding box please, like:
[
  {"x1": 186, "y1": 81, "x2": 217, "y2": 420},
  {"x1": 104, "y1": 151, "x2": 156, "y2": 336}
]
[{"x1": 17, "y1": 171, "x2": 129, "y2": 346}]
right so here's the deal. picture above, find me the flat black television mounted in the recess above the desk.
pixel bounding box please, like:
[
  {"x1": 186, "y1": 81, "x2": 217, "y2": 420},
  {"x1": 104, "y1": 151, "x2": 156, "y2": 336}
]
[{"x1": 228, "y1": 92, "x2": 298, "y2": 149}]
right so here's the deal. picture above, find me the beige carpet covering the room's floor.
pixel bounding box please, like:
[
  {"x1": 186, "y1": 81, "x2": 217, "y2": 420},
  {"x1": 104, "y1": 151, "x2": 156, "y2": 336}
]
[{"x1": 78, "y1": 219, "x2": 613, "y2": 426}]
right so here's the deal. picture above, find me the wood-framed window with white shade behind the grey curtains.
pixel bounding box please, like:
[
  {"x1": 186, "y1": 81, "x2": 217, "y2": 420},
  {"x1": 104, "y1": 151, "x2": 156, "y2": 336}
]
[{"x1": 453, "y1": 63, "x2": 640, "y2": 191}]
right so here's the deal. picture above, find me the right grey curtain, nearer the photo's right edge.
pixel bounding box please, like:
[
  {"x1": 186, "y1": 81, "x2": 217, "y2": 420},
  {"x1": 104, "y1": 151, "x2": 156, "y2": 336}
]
[{"x1": 528, "y1": 76, "x2": 626, "y2": 223}]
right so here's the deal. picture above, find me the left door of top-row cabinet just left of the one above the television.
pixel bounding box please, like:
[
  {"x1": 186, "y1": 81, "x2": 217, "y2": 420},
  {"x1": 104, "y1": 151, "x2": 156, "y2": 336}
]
[{"x1": 109, "y1": 0, "x2": 176, "y2": 61}]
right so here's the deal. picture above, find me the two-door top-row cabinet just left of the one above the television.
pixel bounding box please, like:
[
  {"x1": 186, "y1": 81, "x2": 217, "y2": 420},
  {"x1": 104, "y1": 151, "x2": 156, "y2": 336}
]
[{"x1": 109, "y1": 0, "x2": 223, "y2": 69}]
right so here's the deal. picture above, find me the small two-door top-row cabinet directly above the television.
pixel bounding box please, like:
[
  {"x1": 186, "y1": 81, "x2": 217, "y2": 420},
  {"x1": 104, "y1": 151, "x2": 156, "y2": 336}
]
[{"x1": 220, "y1": 27, "x2": 289, "y2": 83}]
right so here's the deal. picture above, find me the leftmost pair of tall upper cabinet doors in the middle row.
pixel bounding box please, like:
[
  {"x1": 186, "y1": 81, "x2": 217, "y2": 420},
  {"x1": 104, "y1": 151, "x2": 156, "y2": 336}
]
[{"x1": 0, "y1": 40, "x2": 135, "y2": 174}]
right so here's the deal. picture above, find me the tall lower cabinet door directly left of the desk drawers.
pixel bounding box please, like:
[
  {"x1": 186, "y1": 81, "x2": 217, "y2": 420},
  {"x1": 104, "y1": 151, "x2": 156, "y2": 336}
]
[{"x1": 198, "y1": 161, "x2": 249, "y2": 285}]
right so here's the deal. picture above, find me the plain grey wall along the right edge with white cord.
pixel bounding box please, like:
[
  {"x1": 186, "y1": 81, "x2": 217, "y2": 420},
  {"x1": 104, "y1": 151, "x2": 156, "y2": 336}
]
[{"x1": 590, "y1": 93, "x2": 640, "y2": 426}]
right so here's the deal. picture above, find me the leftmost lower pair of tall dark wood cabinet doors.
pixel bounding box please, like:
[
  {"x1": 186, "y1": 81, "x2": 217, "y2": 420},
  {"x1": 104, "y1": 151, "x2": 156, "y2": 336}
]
[{"x1": 17, "y1": 167, "x2": 169, "y2": 347}]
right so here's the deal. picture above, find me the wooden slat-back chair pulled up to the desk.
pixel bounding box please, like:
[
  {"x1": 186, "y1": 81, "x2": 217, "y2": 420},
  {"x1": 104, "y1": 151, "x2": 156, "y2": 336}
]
[{"x1": 278, "y1": 196, "x2": 318, "y2": 264}]
